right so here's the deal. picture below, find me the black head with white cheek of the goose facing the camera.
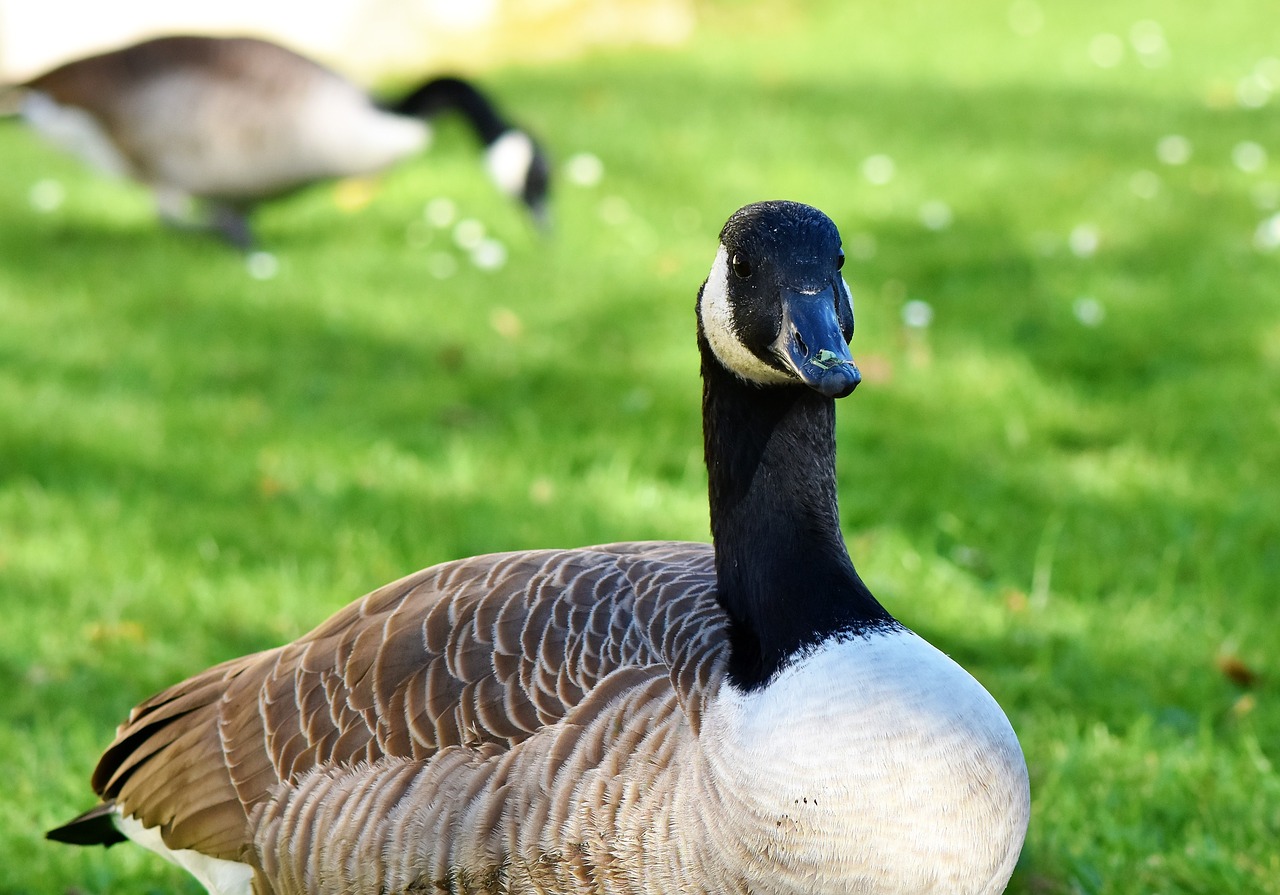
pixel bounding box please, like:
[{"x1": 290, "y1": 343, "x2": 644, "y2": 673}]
[{"x1": 698, "y1": 201, "x2": 861, "y2": 398}]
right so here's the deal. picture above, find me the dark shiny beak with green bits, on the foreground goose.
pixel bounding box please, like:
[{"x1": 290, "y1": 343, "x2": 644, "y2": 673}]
[{"x1": 773, "y1": 286, "x2": 863, "y2": 398}]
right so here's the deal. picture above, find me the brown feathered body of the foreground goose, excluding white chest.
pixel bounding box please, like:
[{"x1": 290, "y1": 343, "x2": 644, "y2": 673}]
[{"x1": 93, "y1": 543, "x2": 727, "y2": 892}]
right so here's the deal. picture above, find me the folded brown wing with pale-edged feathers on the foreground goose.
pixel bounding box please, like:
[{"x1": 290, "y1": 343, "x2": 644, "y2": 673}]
[{"x1": 80, "y1": 543, "x2": 726, "y2": 859}]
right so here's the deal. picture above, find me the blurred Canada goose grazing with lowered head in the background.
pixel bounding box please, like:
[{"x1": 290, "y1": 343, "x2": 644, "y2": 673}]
[{"x1": 8, "y1": 36, "x2": 549, "y2": 247}]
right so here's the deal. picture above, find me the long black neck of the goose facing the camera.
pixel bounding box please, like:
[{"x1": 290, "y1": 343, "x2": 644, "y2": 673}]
[{"x1": 699, "y1": 335, "x2": 892, "y2": 689}]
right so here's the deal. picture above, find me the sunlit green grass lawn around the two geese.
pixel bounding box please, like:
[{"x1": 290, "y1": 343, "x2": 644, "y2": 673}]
[{"x1": 0, "y1": 0, "x2": 1280, "y2": 895}]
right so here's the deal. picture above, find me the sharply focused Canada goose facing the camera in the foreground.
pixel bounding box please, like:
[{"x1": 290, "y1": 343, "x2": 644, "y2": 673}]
[{"x1": 49, "y1": 202, "x2": 1029, "y2": 895}]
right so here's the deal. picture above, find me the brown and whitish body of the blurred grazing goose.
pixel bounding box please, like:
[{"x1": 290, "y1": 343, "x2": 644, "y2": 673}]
[{"x1": 26, "y1": 36, "x2": 429, "y2": 202}]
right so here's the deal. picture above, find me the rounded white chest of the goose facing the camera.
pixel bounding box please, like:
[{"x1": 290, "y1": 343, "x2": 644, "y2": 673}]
[{"x1": 703, "y1": 630, "x2": 1029, "y2": 895}]
